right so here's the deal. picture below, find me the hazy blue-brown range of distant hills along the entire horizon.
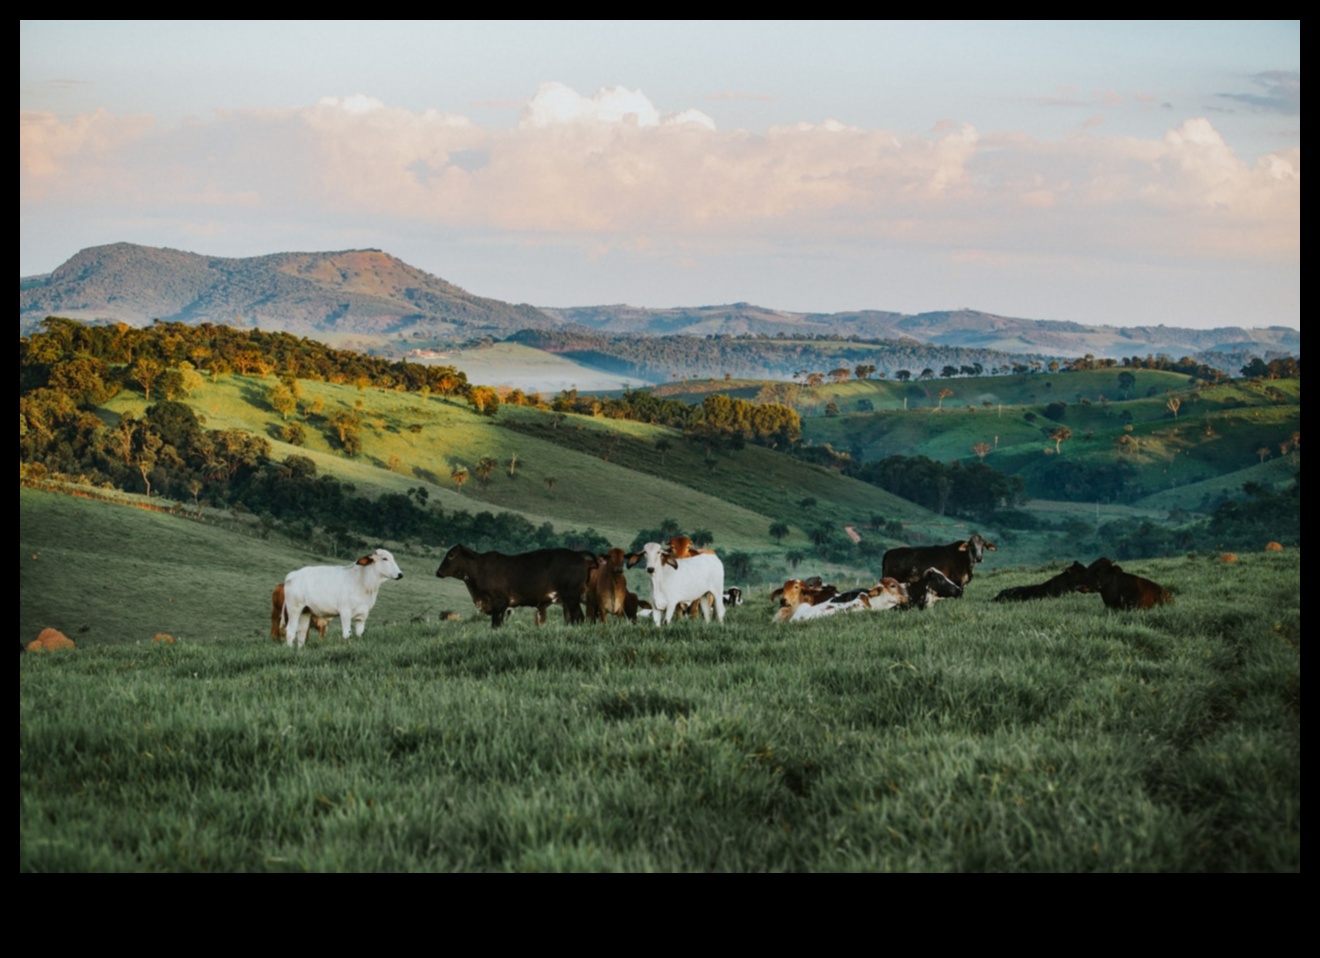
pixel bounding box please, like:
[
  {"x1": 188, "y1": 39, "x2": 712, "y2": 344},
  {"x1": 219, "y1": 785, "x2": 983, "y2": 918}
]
[{"x1": 18, "y1": 243, "x2": 1302, "y2": 372}]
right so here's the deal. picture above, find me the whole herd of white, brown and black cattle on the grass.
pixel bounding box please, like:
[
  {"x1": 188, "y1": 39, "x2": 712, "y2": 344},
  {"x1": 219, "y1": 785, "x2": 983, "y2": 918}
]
[{"x1": 271, "y1": 533, "x2": 1173, "y2": 648}]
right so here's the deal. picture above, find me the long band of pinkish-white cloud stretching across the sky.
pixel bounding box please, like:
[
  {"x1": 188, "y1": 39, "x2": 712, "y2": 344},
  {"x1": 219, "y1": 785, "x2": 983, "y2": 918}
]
[{"x1": 20, "y1": 83, "x2": 1302, "y2": 270}]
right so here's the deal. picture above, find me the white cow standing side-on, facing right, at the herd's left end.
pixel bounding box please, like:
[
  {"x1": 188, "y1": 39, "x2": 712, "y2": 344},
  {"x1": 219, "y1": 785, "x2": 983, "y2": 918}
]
[{"x1": 284, "y1": 549, "x2": 404, "y2": 649}]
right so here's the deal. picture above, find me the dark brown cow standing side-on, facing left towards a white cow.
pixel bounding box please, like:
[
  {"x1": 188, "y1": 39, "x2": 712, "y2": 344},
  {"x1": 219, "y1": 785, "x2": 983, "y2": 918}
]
[{"x1": 436, "y1": 545, "x2": 595, "y2": 628}]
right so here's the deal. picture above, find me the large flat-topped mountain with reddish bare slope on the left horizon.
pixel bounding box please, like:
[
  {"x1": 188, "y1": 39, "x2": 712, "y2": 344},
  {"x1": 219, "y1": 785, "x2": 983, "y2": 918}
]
[{"x1": 18, "y1": 243, "x2": 554, "y2": 339}]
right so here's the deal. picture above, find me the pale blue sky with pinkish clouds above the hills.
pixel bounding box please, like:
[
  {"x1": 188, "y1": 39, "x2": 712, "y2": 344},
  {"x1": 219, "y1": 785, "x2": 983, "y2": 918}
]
[{"x1": 18, "y1": 20, "x2": 1302, "y2": 329}]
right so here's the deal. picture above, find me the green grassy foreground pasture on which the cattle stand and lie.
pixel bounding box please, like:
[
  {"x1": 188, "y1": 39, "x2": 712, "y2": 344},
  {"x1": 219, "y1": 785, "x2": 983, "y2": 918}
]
[{"x1": 18, "y1": 491, "x2": 1302, "y2": 872}]
